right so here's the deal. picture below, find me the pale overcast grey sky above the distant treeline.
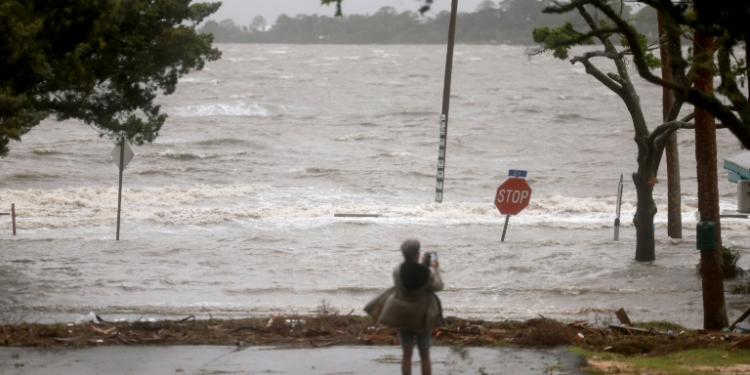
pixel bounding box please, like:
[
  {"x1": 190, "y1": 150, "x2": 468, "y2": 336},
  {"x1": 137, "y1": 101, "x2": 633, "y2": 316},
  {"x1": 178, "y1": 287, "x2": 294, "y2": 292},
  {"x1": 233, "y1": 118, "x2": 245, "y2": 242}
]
[{"x1": 201, "y1": 0, "x2": 488, "y2": 25}]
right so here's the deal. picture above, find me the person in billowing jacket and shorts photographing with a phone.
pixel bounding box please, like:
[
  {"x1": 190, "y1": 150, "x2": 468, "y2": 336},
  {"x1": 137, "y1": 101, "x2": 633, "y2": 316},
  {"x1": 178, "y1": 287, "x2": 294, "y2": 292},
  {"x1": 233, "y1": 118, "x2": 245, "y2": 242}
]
[{"x1": 365, "y1": 239, "x2": 444, "y2": 375}]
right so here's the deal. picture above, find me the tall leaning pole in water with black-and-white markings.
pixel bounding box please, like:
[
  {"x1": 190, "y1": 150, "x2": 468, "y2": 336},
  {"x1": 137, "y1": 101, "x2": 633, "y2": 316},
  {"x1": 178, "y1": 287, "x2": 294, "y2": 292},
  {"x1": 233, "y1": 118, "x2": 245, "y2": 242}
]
[{"x1": 435, "y1": 0, "x2": 458, "y2": 203}]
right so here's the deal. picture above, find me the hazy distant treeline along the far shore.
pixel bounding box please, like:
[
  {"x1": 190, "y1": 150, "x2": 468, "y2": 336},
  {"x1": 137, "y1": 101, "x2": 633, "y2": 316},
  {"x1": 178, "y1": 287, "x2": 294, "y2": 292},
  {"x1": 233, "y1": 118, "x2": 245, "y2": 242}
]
[{"x1": 200, "y1": 0, "x2": 657, "y2": 45}]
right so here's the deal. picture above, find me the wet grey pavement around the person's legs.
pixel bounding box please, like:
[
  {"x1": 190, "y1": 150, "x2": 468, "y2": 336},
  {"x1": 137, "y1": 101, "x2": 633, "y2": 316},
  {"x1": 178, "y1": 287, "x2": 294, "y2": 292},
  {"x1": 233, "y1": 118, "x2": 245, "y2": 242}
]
[{"x1": 0, "y1": 346, "x2": 584, "y2": 375}]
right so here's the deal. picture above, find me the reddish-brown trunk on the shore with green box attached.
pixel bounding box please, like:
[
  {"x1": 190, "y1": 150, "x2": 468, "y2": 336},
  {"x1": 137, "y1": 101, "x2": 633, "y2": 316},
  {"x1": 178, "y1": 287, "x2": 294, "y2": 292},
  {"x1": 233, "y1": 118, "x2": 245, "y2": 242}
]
[{"x1": 693, "y1": 9, "x2": 729, "y2": 330}]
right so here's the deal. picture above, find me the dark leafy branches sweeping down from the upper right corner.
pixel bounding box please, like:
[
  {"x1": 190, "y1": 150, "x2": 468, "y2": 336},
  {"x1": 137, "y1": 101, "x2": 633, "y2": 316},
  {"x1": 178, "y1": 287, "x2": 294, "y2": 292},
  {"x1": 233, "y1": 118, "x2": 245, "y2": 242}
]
[{"x1": 544, "y1": 0, "x2": 750, "y2": 148}]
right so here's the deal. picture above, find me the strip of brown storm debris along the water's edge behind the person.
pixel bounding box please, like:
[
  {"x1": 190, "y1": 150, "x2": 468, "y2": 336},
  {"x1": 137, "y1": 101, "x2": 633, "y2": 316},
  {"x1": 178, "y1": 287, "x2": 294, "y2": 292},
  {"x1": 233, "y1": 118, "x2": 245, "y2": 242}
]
[{"x1": 0, "y1": 315, "x2": 750, "y2": 356}]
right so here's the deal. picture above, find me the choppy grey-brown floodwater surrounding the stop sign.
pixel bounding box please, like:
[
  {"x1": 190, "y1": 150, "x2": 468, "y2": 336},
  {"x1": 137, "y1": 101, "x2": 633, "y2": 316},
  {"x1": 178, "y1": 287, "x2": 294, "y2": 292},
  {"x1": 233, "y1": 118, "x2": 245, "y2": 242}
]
[{"x1": 0, "y1": 44, "x2": 750, "y2": 327}]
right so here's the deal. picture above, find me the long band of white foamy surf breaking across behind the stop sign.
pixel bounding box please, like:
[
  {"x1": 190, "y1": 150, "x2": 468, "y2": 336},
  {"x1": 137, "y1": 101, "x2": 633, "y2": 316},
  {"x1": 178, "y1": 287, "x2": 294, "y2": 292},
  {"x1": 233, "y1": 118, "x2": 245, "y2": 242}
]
[{"x1": 0, "y1": 194, "x2": 750, "y2": 230}]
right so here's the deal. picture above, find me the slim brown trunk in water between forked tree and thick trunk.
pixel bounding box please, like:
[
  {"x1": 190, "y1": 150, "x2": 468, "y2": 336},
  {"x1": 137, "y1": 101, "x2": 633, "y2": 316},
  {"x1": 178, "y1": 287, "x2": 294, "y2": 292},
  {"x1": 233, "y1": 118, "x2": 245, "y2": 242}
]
[{"x1": 658, "y1": 12, "x2": 682, "y2": 238}]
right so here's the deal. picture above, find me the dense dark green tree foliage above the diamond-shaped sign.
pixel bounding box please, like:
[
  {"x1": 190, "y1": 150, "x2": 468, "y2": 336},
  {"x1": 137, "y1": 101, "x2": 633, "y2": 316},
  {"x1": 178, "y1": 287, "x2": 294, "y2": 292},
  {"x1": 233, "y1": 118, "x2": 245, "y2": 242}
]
[{"x1": 0, "y1": 0, "x2": 221, "y2": 156}]
